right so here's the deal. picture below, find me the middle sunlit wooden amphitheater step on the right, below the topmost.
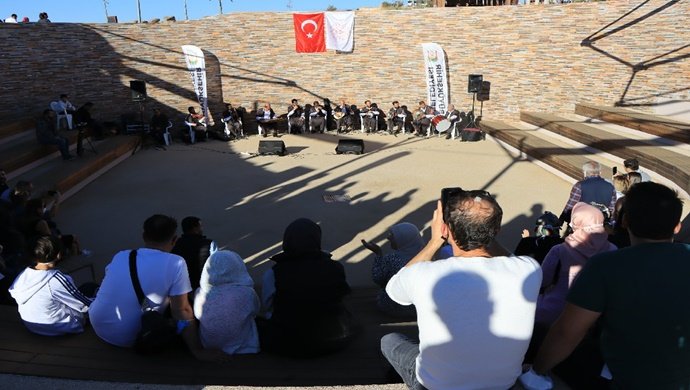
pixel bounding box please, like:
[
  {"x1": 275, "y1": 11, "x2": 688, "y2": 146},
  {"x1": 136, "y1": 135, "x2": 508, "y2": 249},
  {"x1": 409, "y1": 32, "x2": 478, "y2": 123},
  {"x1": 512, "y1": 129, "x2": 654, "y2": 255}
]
[{"x1": 520, "y1": 112, "x2": 690, "y2": 192}]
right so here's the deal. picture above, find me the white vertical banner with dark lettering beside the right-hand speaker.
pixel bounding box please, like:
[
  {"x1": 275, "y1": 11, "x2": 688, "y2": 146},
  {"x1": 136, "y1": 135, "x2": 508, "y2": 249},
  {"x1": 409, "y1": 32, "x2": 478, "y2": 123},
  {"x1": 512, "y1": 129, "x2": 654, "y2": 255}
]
[{"x1": 422, "y1": 43, "x2": 448, "y2": 114}]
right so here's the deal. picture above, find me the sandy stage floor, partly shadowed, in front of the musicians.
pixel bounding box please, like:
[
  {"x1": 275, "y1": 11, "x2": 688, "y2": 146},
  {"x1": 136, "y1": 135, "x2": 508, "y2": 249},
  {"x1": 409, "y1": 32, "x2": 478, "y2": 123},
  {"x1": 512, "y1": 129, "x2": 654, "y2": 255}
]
[{"x1": 58, "y1": 133, "x2": 572, "y2": 287}]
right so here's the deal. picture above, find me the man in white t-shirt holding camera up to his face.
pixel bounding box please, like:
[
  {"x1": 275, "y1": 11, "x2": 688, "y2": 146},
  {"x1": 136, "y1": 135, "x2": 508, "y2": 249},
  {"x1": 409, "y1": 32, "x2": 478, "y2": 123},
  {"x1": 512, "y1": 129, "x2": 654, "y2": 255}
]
[{"x1": 381, "y1": 191, "x2": 541, "y2": 390}]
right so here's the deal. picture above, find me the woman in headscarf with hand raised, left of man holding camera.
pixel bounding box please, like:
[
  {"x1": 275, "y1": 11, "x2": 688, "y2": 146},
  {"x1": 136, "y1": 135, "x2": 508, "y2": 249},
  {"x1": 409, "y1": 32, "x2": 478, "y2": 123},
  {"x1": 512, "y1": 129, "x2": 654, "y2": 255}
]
[{"x1": 362, "y1": 222, "x2": 424, "y2": 317}]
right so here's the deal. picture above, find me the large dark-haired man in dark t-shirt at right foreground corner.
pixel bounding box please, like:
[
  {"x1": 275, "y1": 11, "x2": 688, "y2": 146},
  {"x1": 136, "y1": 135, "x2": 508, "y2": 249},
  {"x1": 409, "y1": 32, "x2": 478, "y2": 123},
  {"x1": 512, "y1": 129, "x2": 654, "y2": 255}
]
[{"x1": 523, "y1": 182, "x2": 690, "y2": 389}]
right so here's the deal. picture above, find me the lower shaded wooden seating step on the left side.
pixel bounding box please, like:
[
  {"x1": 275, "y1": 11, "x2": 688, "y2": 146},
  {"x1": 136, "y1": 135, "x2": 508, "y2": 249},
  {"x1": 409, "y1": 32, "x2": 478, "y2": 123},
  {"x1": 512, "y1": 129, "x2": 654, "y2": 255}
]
[{"x1": 8, "y1": 136, "x2": 139, "y2": 197}]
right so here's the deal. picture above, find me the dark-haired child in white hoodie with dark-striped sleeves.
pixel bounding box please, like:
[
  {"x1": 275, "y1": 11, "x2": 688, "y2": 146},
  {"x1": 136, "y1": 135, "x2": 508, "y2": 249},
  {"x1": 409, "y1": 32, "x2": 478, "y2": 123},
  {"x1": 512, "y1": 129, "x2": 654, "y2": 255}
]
[{"x1": 9, "y1": 236, "x2": 92, "y2": 336}]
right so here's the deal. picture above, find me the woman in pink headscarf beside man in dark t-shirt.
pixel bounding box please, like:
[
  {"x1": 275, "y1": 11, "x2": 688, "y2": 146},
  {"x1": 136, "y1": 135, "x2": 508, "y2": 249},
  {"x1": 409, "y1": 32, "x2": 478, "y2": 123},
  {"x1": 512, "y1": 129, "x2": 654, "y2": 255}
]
[{"x1": 536, "y1": 202, "x2": 617, "y2": 326}]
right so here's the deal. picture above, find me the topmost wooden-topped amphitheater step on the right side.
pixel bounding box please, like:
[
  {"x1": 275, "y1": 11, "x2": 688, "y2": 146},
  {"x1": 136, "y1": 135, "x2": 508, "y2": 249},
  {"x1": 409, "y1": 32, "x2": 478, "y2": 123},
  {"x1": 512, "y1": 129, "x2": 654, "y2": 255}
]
[{"x1": 575, "y1": 103, "x2": 690, "y2": 144}]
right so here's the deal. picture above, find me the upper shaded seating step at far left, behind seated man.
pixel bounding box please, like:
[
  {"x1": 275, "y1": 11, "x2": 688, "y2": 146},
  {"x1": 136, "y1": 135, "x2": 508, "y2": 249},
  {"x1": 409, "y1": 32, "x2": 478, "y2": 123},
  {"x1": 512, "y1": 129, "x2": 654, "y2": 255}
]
[{"x1": 0, "y1": 127, "x2": 77, "y2": 178}]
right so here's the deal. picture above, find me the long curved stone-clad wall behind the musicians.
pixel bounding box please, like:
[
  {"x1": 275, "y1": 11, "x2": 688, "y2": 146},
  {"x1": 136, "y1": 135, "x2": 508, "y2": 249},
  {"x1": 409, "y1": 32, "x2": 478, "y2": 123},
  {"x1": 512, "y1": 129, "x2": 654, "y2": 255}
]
[{"x1": 0, "y1": 0, "x2": 690, "y2": 124}]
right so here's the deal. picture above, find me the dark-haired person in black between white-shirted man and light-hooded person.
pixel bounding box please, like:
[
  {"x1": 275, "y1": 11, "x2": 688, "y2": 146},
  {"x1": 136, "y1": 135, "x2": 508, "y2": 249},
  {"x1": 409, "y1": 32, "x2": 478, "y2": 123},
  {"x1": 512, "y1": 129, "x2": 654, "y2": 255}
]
[{"x1": 172, "y1": 217, "x2": 218, "y2": 289}]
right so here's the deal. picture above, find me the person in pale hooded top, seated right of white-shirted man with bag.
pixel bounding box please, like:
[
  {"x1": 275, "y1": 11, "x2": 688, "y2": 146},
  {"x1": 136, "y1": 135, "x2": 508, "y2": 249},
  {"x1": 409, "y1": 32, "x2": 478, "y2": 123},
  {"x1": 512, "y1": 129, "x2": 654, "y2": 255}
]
[{"x1": 194, "y1": 251, "x2": 260, "y2": 355}]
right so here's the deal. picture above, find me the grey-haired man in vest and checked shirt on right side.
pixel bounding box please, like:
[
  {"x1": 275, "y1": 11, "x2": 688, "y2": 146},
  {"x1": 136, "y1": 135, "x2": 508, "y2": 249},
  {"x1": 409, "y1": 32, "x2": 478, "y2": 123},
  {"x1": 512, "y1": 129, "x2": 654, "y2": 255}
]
[{"x1": 558, "y1": 161, "x2": 616, "y2": 222}]
